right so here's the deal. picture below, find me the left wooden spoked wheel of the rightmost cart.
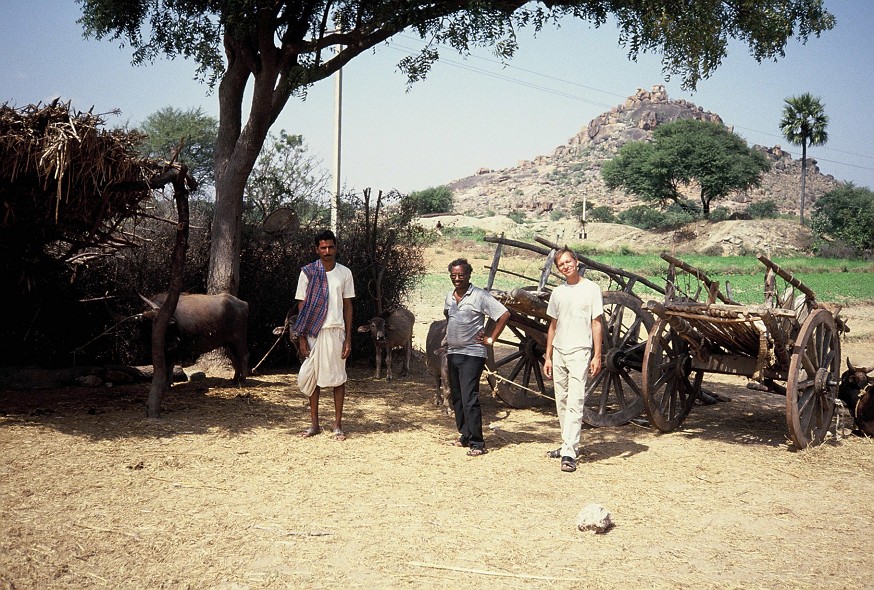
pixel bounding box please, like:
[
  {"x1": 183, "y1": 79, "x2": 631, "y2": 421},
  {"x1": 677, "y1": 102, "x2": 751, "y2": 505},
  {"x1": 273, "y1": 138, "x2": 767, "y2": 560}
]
[{"x1": 642, "y1": 319, "x2": 704, "y2": 432}]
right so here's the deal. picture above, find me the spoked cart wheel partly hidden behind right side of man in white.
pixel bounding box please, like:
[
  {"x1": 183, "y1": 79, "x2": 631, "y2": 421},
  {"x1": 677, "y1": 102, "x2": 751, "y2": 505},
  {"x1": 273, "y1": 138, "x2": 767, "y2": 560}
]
[{"x1": 583, "y1": 291, "x2": 654, "y2": 426}]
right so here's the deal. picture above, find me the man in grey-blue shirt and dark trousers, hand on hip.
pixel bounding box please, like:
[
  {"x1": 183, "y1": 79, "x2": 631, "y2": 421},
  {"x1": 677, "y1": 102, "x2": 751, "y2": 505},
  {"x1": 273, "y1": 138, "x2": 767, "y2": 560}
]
[{"x1": 443, "y1": 258, "x2": 510, "y2": 457}]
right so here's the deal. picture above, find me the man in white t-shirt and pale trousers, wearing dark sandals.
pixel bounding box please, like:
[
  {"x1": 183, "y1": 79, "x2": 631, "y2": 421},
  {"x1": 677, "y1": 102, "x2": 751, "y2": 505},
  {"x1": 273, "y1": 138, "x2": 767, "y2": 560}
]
[{"x1": 543, "y1": 247, "x2": 604, "y2": 472}]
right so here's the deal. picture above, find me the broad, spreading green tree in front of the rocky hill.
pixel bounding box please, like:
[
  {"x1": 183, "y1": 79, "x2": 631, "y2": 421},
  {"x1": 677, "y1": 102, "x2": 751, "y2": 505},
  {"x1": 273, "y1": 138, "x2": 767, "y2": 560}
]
[{"x1": 601, "y1": 119, "x2": 770, "y2": 219}]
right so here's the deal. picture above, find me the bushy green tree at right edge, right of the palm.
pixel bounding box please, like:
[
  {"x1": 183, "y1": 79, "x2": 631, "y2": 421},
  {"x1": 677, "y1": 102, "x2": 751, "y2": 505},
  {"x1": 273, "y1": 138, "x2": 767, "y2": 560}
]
[{"x1": 811, "y1": 183, "x2": 874, "y2": 256}]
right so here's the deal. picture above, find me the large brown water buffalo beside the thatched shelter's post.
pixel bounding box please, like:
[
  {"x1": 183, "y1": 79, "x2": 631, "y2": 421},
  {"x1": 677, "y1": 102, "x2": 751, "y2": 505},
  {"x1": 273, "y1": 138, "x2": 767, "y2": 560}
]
[{"x1": 142, "y1": 293, "x2": 249, "y2": 383}]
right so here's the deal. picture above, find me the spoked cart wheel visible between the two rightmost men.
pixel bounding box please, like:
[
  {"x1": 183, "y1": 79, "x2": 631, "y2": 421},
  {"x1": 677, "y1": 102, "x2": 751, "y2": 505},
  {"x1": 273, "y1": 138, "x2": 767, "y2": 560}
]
[{"x1": 487, "y1": 324, "x2": 554, "y2": 408}]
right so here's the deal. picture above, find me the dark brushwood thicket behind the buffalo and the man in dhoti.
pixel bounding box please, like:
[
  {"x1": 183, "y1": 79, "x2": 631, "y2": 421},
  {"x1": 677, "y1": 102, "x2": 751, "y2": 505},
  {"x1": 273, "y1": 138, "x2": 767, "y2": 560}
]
[{"x1": 39, "y1": 194, "x2": 428, "y2": 366}]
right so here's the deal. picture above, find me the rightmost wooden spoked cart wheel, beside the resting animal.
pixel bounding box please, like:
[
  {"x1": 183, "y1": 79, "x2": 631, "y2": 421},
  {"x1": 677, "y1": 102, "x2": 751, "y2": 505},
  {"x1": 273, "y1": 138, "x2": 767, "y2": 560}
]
[{"x1": 786, "y1": 309, "x2": 841, "y2": 449}]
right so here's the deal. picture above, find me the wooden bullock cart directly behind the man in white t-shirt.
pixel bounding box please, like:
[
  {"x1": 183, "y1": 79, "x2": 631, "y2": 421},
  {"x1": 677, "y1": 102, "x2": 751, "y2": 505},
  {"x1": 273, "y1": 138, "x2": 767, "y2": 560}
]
[{"x1": 476, "y1": 235, "x2": 665, "y2": 426}]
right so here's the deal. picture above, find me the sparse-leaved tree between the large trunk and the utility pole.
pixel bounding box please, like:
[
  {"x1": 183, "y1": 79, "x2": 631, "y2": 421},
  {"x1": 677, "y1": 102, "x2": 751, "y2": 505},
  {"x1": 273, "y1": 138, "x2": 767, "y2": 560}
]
[{"x1": 245, "y1": 129, "x2": 330, "y2": 223}]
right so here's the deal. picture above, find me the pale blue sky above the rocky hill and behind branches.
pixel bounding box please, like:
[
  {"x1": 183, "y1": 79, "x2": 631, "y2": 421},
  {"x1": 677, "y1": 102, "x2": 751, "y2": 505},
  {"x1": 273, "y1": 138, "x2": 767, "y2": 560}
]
[{"x1": 0, "y1": 0, "x2": 874, "y2": 193}]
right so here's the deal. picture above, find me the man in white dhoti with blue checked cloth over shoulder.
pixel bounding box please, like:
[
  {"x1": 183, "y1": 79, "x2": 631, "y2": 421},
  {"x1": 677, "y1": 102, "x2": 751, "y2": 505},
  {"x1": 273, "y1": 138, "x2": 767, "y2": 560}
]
[{"x1": 295, "y1": 230, "x2": 355, "y2": 440}]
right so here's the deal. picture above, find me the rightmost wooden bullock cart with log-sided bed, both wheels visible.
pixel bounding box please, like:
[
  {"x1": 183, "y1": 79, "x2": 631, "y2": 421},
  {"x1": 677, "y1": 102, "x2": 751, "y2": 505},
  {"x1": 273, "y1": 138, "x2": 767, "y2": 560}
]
[{"x1": 642, "y1": 254, "x2": 848, "y2": 448}]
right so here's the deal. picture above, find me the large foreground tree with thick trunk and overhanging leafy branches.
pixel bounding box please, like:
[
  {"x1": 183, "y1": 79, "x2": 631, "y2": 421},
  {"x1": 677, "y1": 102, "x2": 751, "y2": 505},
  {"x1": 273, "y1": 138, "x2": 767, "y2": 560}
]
[{"x1": 77, "y1": 0, "x2": 835, "y2": 293}]
